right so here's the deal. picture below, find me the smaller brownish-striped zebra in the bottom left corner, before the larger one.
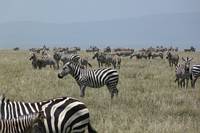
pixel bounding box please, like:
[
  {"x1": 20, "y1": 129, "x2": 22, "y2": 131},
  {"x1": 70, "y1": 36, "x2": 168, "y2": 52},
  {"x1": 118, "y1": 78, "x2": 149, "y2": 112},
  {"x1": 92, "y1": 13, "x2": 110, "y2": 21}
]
[{"x1": 0, "y1": 111, "x2": 45, "y2": 133}]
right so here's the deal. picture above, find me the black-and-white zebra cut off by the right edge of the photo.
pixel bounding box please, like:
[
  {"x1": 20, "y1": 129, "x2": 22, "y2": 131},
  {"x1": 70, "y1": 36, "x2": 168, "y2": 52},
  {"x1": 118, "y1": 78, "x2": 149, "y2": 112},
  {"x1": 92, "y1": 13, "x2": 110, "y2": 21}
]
[{"x1": 191, "y1": 64, "x2": 200, "y2": 88}]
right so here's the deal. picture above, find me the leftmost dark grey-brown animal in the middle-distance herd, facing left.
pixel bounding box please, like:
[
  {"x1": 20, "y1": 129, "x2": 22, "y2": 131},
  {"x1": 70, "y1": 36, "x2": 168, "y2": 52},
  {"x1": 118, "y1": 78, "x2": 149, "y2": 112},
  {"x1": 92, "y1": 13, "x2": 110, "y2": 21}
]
[{"x1": 29, "y1": 53, "x2": 55, "y2": 69}]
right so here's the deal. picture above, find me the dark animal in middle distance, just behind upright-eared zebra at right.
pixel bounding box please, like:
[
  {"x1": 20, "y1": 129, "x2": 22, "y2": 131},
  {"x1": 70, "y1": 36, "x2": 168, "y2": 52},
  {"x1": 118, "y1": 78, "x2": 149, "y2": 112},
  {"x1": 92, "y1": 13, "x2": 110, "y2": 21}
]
[{"x1": 166, "y1": 51, "x2": 179, "y2": 67}]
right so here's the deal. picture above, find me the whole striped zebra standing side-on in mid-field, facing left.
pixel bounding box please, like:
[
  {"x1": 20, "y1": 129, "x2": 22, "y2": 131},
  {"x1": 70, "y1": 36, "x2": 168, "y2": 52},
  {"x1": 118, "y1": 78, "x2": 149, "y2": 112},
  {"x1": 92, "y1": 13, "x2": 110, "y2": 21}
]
[{"x1": 58, "y1": 62, "x2": 119, "y2": 99}]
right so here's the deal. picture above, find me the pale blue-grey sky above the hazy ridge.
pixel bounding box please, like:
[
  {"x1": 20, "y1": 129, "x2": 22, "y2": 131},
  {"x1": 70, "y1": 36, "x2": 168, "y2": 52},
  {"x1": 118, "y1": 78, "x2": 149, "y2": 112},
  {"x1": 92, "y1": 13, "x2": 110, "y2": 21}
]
[{"x1": 0, "y1": 0, "x2": 200, "y2": 23}]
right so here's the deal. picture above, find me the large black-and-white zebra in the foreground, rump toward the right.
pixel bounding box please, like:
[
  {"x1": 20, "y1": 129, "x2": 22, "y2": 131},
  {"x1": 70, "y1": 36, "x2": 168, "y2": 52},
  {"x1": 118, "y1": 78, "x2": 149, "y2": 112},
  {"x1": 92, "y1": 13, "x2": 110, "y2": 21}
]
[{"x1": 0, "y1": 96, "x2": 96, "y2": 133}]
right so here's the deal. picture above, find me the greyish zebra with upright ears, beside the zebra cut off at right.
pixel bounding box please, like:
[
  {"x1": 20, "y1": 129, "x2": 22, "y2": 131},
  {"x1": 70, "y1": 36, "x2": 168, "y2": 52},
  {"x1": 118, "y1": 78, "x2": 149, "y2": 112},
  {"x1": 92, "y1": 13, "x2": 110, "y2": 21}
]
[{"x1": 175, "y1": 57, "x2": 193, "y2": 88}]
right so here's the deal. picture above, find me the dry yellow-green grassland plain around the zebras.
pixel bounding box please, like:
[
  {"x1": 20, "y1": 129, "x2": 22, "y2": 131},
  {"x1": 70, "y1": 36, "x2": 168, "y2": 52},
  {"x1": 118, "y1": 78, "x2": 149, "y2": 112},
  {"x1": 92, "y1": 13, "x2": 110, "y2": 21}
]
[{"x1": 0, "y1": 50, "x2": 200, "y2": 133}]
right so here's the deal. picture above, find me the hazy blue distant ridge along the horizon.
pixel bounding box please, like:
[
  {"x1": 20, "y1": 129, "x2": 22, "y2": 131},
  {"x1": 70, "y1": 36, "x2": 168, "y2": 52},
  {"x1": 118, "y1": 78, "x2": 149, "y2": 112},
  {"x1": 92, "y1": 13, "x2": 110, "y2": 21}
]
[{"x1": 0, "y1": 13, "x2": 200, "y2": 48}]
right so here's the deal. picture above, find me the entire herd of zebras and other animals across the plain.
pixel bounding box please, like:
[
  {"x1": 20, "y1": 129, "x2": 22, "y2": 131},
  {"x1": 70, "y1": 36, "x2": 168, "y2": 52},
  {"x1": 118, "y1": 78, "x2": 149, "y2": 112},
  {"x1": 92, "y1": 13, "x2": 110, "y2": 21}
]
[{"x1": 0, "y1": 47, "x2": 200, "y2": 133}]
